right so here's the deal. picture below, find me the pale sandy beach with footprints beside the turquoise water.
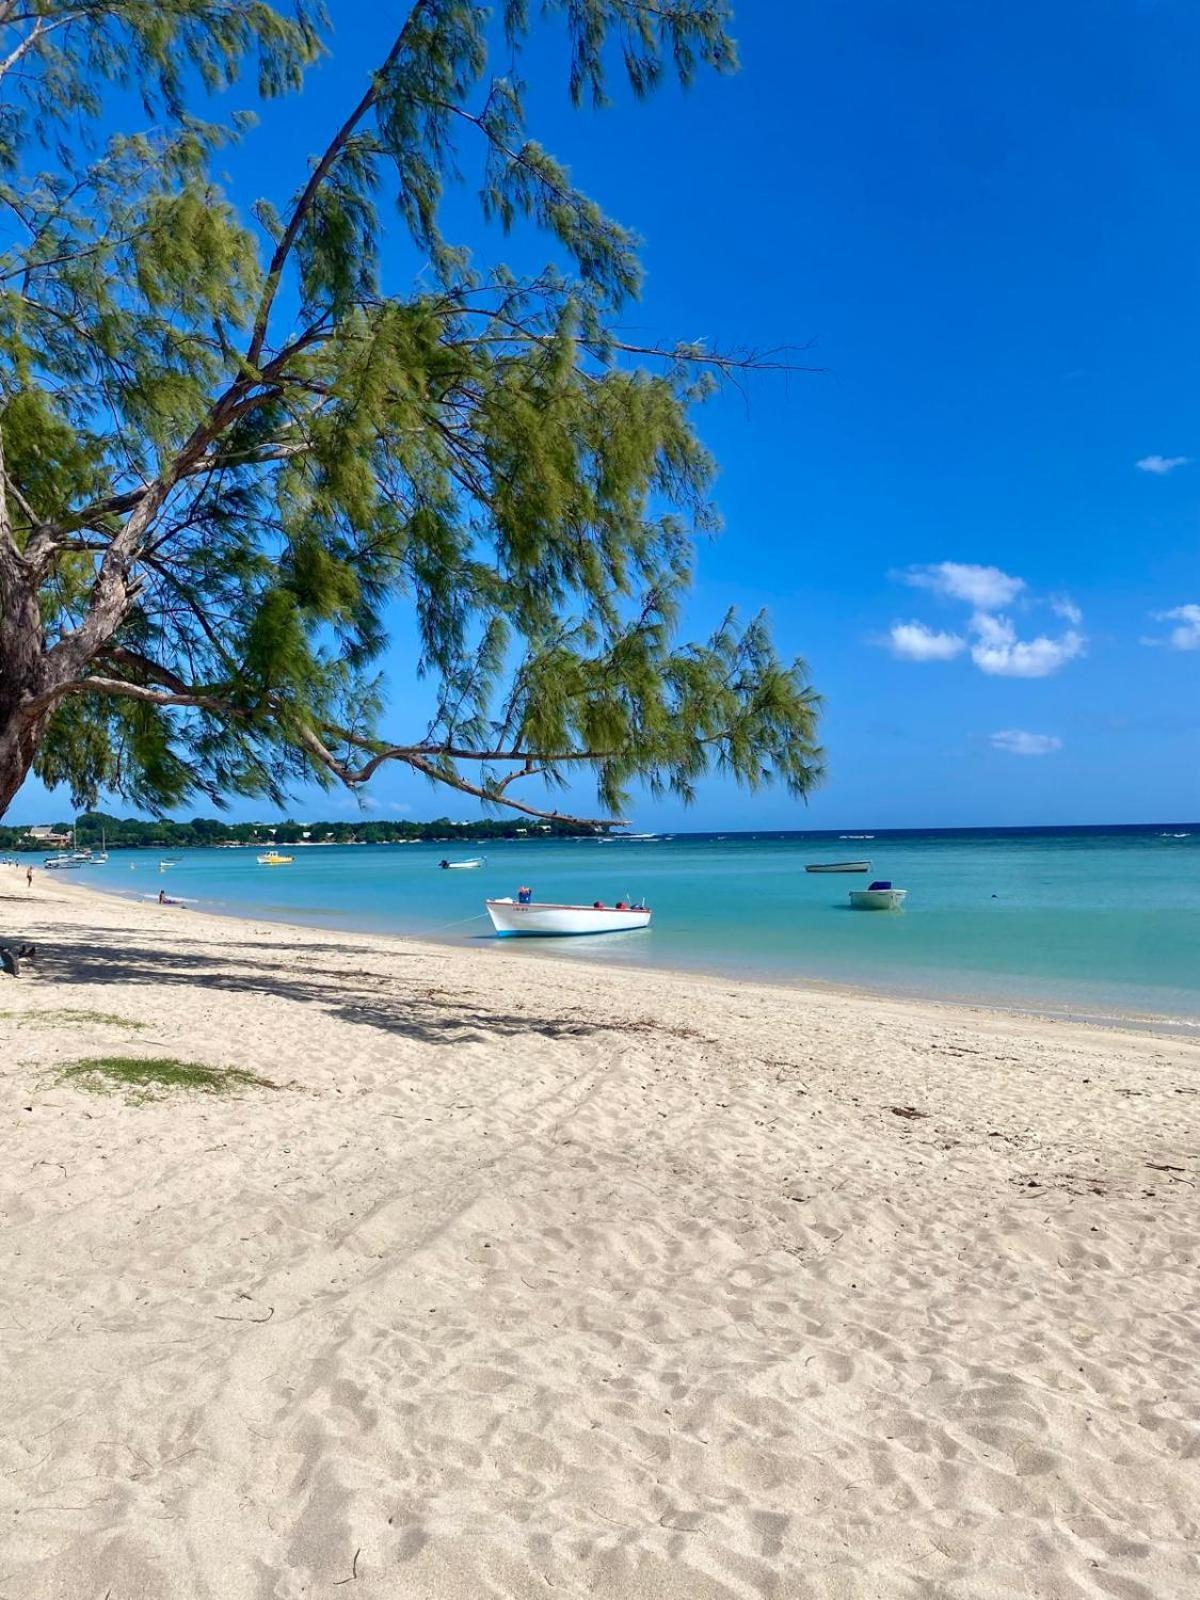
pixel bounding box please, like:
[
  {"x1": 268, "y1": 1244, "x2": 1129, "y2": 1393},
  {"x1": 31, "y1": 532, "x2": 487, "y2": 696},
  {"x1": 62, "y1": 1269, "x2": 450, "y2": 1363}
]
[{"x1": 0, "y1": 869, "x2": 1200, "y2": 1600}]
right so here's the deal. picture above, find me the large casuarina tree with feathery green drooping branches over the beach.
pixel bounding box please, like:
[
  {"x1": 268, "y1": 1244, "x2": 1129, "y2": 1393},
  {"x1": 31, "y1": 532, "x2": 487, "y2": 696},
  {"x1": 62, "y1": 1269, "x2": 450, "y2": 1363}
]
[{"x1": 0, "y1": 0, "x2": 819, "y2": 816}]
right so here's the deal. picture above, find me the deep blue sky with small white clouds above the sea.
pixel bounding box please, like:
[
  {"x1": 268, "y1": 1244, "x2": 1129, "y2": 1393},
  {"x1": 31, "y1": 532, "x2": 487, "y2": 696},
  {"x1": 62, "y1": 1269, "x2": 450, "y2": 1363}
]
[{"x1": 11, "y1": 0, "x2": 1200, "y2": 827}]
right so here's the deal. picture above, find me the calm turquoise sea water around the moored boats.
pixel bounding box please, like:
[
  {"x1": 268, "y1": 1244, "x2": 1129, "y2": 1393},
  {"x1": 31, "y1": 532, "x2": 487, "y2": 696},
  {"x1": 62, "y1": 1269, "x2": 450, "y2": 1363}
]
[{"x1": 75, "y1": 824, "x2": 1200, "y2": 1018}]
